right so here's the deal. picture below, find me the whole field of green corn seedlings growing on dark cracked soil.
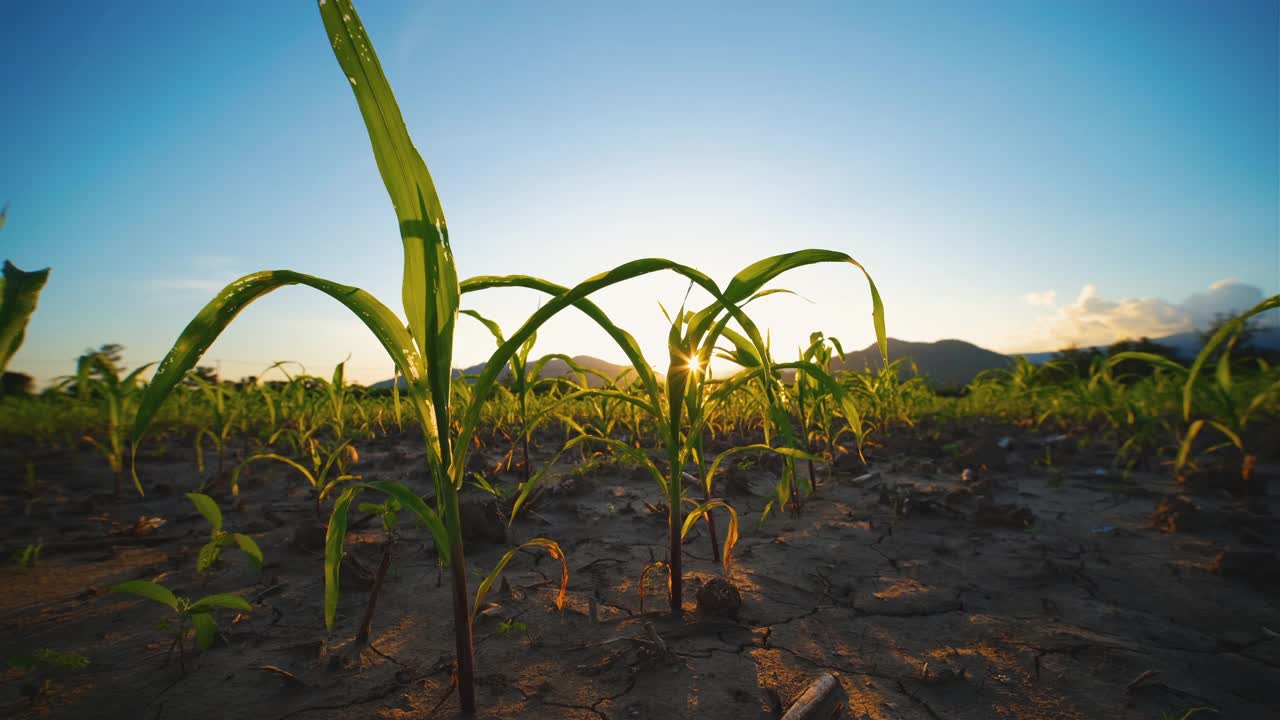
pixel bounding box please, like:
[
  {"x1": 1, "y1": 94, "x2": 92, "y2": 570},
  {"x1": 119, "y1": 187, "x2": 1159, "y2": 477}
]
[{"x1": 0, "y1": 0, "x2": 1280, "y2": 720}]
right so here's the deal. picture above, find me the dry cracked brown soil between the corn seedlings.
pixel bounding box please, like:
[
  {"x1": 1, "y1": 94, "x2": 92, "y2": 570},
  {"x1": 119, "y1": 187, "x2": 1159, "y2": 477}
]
[{"x1": 0, "y1": 430, "x2": 1280, "y2": 720}]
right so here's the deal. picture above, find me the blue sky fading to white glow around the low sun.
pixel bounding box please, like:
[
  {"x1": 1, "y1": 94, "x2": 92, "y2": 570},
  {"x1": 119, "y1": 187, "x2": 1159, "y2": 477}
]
[{"x1": 0, "y1": 1, "x2": 1280, "y2": 380}]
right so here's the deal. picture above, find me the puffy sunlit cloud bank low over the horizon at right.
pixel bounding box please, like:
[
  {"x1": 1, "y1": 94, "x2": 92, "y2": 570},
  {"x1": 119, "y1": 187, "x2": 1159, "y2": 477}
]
[{"x1": 1021, "y1": 279, "x2": 1263, "y2": 350}]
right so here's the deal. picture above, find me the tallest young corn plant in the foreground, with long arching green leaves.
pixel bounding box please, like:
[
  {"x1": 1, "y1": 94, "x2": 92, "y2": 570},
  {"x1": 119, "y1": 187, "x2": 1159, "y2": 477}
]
[{"x1": 120, "y1": 0, "x2": 650, "y2": 715}]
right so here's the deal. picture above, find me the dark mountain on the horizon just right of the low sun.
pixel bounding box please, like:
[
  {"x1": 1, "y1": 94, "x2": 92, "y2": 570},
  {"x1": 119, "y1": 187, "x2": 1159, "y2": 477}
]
[{"x1": 831, "y1": 337, "x2": 1014, "y2": 387}]
